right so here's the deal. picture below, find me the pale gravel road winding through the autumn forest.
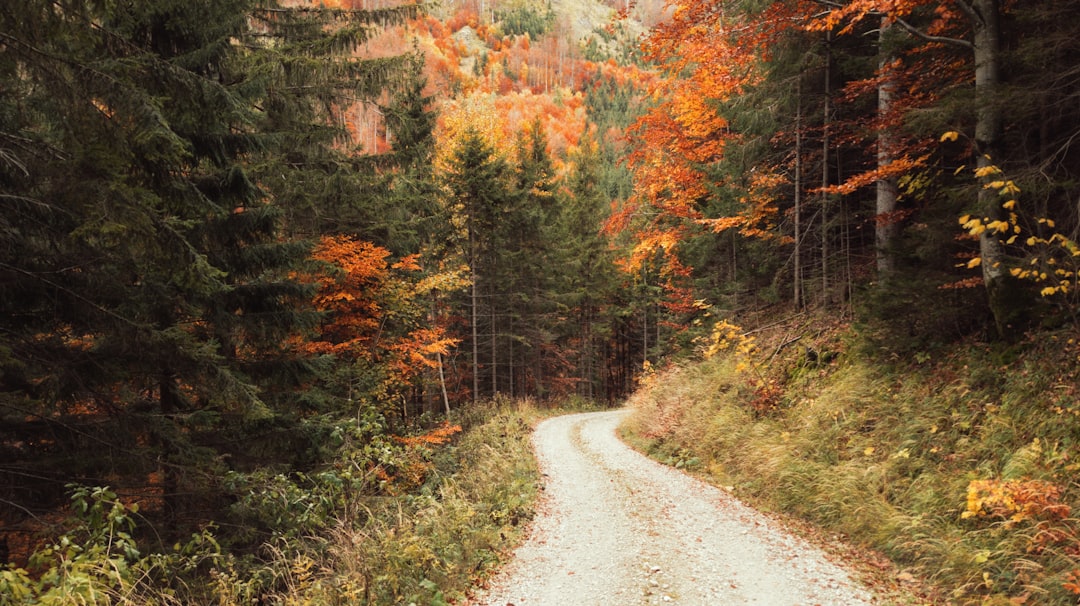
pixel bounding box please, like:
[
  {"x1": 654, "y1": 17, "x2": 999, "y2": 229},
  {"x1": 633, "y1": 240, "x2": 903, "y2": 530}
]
[{"x1": 473, "y1": 410, "x2": 875, "y2": 606}]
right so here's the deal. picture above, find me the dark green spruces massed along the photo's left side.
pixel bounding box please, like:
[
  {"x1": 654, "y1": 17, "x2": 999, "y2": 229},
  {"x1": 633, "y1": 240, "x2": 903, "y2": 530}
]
[{"x1": 0, "y1": 0, "x2": 415, "y2": 553}]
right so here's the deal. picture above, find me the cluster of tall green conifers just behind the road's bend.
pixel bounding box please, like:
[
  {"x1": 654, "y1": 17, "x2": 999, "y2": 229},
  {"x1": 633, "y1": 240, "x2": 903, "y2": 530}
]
[{"x1": 444, "y1": 113, "x2": 626, "y2": 398}]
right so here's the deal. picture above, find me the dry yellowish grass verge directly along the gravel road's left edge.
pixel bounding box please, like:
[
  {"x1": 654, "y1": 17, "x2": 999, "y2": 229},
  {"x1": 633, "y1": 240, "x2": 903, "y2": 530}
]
[{"x1": 238, "y1": 402, "x2": 544, "y2": 606}]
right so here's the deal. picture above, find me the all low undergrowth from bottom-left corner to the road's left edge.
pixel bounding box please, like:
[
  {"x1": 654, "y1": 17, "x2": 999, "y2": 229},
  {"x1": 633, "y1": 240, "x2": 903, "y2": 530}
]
[{"x1": 0, "y1": 402, "x2": 550, "y2": 606}]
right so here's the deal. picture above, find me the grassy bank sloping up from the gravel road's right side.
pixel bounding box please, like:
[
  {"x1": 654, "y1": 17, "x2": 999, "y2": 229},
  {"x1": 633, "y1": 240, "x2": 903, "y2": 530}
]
[{"x1": 626, "y1": 324, "x2": 1080, "y2": 604}]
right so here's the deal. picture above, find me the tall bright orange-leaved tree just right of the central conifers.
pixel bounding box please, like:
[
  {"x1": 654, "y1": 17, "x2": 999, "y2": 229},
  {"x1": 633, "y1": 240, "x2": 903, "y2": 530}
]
[{"x1": 605, "y1": 0, "x2": 806, "y2": 311}]
